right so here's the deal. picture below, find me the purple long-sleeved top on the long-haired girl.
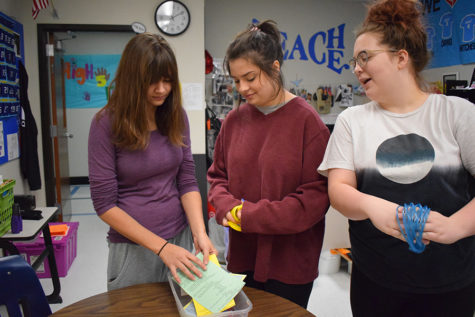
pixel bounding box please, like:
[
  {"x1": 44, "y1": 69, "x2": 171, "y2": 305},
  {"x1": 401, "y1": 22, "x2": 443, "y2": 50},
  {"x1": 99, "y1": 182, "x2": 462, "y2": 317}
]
[{"x1": 88, "y1": 112, "x2": 199, "y2": 243}]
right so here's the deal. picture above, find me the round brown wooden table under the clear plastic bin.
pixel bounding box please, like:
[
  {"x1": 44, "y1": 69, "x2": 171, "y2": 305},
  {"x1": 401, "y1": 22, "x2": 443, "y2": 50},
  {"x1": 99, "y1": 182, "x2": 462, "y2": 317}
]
[{"x1": 52, "y1": 282, "x2": 314, "y2": 317}]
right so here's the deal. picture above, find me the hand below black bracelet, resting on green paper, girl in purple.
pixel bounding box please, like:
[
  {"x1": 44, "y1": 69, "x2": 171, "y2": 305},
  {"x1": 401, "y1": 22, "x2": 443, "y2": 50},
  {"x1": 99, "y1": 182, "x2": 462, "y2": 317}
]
[{"x1": 160, "y1": 243, "x2": 206, "y2": 283}]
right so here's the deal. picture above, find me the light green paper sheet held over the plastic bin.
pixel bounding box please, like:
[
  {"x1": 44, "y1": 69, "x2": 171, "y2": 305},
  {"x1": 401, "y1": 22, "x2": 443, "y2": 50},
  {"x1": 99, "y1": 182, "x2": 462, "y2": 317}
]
[{"x1": 175, "y1": 253, "x2": 244, "y2": 313}]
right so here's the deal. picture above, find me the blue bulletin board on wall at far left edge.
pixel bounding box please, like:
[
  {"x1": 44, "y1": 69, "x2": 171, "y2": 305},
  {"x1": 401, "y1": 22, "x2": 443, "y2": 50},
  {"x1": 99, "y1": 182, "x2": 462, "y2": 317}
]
[{"x1": 0, "y1": 12, "x2": 24, "y2": 164}]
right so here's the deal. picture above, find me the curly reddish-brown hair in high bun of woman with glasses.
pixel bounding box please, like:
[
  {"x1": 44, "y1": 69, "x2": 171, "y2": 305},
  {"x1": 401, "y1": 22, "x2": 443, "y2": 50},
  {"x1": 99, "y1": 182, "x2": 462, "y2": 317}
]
[{"x1": 356, "y1": 0, "x2": 430, "y2": 88}]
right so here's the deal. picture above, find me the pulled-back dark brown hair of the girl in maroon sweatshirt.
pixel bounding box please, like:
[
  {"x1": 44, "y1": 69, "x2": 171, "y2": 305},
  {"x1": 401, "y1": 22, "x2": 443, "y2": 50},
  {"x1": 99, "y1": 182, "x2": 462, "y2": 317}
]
[{"x1": 224, "y1": 20, "x2": 284, "y2": 101}]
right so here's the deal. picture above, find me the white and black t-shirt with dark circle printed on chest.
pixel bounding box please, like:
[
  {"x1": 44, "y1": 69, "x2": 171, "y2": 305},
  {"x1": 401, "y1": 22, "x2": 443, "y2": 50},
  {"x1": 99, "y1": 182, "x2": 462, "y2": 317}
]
[{"x1": 318, "y1": 95, "x2": 475, "y2": 293}]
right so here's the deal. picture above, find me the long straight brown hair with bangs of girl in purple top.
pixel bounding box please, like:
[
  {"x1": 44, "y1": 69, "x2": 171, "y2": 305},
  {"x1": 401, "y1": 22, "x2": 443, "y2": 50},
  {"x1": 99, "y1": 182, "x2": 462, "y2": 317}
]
[{"x1": 99, "y1": 33, "x2": 185, "y2": 150}]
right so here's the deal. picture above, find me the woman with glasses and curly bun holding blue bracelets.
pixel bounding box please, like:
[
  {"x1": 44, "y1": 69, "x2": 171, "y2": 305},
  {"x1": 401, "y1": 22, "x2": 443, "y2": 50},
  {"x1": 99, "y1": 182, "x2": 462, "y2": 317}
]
[{"x1": 319, "y1": 0, "x2": 475, "y2": 317}]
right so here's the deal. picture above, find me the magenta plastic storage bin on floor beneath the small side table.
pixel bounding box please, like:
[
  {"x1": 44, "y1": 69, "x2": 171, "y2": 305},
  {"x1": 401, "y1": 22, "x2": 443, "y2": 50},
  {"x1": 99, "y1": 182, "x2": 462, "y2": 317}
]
[{"x1": 14, "y1": 222, "x2": 79, "y2": 278}]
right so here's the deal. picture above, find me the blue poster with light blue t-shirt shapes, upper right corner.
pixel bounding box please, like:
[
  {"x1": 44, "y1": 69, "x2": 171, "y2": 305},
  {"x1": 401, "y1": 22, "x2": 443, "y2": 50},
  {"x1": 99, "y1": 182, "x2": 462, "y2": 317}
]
[{"x1": 426, "y1": 0, "x2": 475, "y2": 68}]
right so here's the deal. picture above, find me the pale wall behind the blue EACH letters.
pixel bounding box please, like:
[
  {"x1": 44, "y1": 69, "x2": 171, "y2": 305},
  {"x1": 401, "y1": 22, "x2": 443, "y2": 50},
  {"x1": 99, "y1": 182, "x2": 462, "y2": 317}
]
[{"x1": 205, "y1": 0, "x2": 365, "y2": 87}]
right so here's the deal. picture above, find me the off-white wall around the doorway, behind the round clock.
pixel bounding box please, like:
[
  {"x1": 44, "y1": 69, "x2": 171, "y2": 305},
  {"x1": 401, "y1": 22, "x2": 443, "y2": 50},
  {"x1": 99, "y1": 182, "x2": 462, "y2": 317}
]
[{"x1": 0, "y1": 0, "x2": 205, "y2": 206}]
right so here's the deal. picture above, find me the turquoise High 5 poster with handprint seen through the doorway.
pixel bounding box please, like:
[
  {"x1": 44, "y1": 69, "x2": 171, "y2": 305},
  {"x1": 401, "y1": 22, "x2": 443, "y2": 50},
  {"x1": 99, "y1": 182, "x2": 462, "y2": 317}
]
[{"x1": 63, "y1": 54, "x2": 121, "y2": 109}]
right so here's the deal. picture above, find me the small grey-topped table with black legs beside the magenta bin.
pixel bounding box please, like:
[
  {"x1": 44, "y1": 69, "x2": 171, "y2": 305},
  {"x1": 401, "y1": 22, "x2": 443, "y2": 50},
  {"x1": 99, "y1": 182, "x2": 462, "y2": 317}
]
[{"x1": 0, "y1": 207, "x2": 63, "y2": 304}]
